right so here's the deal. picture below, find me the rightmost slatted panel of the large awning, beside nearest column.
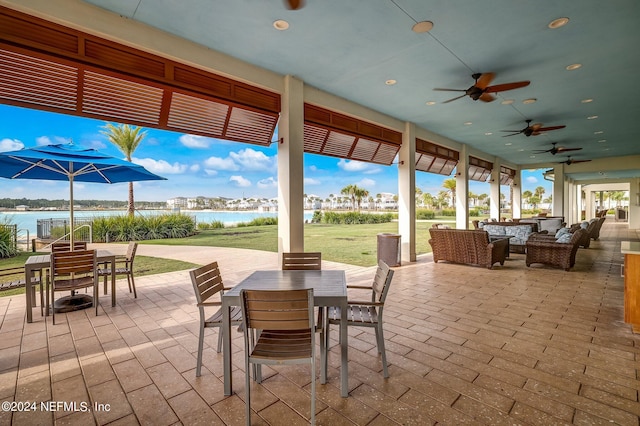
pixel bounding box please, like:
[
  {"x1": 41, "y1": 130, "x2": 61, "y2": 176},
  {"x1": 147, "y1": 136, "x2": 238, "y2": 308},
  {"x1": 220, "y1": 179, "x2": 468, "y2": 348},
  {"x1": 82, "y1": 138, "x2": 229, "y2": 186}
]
[{"x1": 224, "y1": 107, "x2": 278, "y2": 146}]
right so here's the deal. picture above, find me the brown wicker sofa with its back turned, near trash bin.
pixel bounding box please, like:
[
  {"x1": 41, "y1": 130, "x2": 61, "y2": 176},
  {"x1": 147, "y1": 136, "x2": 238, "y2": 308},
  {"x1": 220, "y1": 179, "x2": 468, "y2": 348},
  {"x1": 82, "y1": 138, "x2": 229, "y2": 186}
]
[{"x1": 429, "y1": 227, "x2": 508, "y2": 269}]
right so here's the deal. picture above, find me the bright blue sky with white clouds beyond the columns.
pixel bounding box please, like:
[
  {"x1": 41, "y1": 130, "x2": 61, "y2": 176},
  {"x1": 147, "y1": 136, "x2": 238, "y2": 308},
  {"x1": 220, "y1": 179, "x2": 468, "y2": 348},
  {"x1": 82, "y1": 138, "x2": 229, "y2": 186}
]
[{"x1": 0, "y1": 105, "x2": 551, "y2": 201}]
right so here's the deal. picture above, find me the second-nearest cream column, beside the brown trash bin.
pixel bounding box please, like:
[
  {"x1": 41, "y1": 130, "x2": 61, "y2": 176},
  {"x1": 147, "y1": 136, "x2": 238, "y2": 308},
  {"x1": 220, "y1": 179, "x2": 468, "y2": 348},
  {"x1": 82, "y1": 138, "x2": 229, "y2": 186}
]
[{"x1": 398, "y1": 122, "x2": 416, "y2": 262}]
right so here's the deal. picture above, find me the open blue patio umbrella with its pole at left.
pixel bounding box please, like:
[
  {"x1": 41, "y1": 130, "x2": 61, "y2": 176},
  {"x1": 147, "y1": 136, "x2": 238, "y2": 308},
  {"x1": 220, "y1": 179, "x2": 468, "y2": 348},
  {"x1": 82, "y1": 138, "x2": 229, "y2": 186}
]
[{"x1": 0, "y1": 144, "x2": 166, "y2": 247}]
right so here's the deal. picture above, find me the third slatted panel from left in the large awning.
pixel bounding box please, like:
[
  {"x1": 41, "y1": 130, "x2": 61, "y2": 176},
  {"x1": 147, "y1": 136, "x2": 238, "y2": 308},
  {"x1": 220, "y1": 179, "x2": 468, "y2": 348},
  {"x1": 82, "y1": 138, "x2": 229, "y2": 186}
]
[{"x1": 167, "y1": 92, "x2": 229, "y2": 135}]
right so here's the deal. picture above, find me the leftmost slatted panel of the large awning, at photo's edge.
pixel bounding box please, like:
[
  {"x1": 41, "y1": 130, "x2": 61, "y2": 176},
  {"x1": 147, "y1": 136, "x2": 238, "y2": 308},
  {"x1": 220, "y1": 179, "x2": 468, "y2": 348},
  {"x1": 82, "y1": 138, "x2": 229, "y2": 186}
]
[{"x1": 0, "y1": 49, "x2": 78, "y2": 111}]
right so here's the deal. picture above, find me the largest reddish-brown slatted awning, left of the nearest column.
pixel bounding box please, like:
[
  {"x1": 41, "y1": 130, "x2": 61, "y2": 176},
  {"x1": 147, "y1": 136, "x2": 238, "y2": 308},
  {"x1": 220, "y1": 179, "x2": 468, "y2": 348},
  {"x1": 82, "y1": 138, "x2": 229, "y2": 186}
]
[{"x1": 0, "y1": 6, "x2": 280, "y2": 146}]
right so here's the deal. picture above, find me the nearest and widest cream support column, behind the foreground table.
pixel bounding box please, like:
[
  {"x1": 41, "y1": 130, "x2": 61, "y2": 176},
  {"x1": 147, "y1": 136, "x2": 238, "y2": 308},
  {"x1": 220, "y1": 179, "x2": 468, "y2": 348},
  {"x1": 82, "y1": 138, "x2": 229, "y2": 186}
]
[{"x1": 278, "y1": 75, "x2": 304, "y2": 255}]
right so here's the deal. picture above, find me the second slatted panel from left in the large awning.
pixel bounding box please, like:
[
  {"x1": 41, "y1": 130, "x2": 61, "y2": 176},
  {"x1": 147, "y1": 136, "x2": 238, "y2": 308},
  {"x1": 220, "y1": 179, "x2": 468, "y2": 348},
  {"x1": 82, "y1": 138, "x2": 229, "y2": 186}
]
[{"x1": 82, "y1": 70, "x2": 163, "y2": 126}]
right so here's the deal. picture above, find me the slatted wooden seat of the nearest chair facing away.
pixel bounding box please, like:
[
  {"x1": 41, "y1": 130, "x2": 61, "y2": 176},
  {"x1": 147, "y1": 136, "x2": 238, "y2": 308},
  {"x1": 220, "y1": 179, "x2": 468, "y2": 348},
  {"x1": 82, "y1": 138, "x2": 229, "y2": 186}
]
[{"x1": 251, "y1": 329, "x2": 312, "y2": 363}]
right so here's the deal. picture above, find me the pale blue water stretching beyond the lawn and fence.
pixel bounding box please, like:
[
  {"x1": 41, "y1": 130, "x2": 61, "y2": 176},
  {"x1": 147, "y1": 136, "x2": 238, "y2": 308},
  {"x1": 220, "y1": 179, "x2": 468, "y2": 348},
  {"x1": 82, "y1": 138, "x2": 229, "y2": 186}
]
[{"x1": 0, "y1": 210, "x2": 313, "y2": 239}]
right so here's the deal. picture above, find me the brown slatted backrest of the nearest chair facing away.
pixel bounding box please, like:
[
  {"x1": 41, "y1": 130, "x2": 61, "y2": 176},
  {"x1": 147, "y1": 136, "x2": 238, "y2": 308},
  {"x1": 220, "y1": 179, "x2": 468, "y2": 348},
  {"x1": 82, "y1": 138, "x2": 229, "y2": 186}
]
[{"x1": 240, "y1": 289, "x2": 315, "y2": 330}]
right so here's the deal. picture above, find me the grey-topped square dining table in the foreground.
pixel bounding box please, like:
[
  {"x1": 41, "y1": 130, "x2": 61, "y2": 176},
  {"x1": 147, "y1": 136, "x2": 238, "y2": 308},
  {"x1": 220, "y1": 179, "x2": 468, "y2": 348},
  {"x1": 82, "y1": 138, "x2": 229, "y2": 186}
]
[{"x1": 222, "y1": 270, "x2": 349, "y2": 398}]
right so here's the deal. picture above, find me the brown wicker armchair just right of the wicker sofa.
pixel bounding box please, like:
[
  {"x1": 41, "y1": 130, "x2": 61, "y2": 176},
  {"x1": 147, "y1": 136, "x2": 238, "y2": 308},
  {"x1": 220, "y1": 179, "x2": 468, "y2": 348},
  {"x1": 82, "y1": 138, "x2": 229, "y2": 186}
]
[{"x1": 526, "y1": 229, "x2": 588, "y2": 271}]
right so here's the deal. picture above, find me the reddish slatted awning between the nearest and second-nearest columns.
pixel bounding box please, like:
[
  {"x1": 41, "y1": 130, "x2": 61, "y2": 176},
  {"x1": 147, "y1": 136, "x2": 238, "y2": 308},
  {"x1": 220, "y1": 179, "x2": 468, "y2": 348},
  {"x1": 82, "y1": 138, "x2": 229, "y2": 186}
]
[{"x1": 304, "y1": 104, "x2": 402, "y2": 165}]
